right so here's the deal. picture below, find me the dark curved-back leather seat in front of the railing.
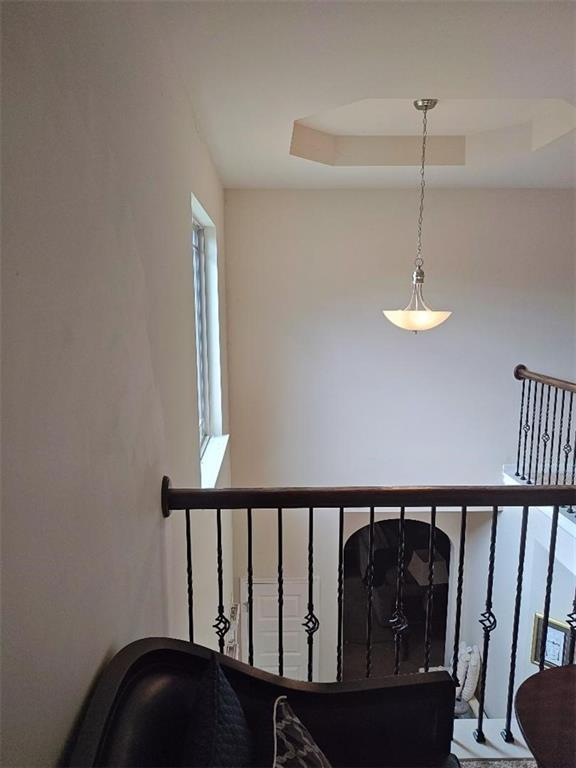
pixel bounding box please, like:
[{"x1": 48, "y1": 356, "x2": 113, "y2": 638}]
[{"x1": 68, "y1": 638, "x2": 458, "y2": 768}]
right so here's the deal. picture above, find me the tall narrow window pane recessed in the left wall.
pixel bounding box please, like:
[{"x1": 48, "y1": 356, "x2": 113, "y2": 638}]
[{"x1": 192, "y1": 222, "x2": 211, "y2": 457}]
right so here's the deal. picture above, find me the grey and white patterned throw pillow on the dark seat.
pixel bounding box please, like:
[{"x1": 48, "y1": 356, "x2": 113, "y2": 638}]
[{"x1": 273, "y1": 696, "x2": 331, "y2": 768}]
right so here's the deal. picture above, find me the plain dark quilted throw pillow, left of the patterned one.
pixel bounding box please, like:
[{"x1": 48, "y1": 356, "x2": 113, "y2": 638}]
[{"x1": 185, "y1": 656, "x2": 253, "y2": 768}]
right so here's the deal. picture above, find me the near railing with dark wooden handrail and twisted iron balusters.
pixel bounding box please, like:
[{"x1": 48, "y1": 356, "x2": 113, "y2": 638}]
[{"x1": 162, "y1": 476, "x2": 576, "y2": 743}]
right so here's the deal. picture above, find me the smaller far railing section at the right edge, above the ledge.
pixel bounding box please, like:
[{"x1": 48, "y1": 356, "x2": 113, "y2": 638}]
[{"x1": 514, "y1": 365, "x2": 576, "y2": 485}]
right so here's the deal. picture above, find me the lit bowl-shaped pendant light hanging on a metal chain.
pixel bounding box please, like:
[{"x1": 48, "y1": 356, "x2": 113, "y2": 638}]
[{"x1": 383, "y1": 99, "x2": 452, "y2": 333}]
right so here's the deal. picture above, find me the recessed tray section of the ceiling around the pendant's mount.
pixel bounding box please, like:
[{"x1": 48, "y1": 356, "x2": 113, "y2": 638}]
[{"x1": 290, "y1": 99, "x2": 576, "y2": 166}]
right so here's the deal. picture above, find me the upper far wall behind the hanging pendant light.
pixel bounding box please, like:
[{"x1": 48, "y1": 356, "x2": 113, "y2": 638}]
[{"x1": 226, "y1": 189, "x2": 576, "y2": 485}]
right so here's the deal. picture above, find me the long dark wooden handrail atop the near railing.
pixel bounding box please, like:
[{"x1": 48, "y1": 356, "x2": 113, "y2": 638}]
[{"x1": 162, "y1": 477, "x2": 576, "y2": 517}]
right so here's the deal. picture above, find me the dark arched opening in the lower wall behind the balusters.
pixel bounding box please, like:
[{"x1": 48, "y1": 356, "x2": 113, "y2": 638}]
[{"x1": 343, "y1": 520, "x2": 450, "y2": 680}]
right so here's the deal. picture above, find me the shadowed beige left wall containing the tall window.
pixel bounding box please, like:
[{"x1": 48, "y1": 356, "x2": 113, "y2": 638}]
[{"x1": 2, "y1": 3, "x2": 230, "y2": 766}]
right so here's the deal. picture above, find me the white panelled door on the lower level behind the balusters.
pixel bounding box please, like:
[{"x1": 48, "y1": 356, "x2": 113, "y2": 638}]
[{"x1": 241, "y1": 579, "x2": 320, "y2": 680}]
